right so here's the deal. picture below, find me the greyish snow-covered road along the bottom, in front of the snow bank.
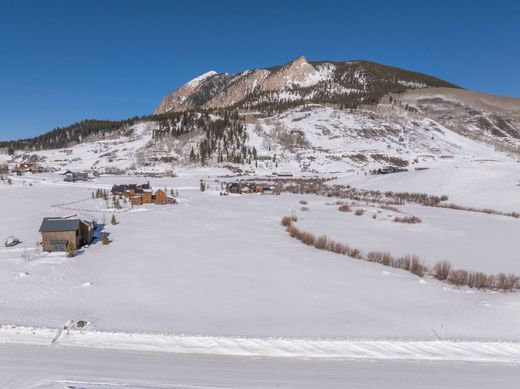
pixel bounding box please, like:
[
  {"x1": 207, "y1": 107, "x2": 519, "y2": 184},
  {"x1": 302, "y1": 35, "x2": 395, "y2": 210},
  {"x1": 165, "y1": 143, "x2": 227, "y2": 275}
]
[{"x1": 0, "y1": 344, "x2": 520, "y2": 389}]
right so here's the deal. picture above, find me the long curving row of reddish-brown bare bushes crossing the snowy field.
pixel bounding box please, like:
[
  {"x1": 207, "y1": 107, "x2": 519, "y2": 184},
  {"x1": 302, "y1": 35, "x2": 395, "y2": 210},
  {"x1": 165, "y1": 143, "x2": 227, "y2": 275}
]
[{"x1": 281, "y1": 215, "x2": 520, "y2": 292}]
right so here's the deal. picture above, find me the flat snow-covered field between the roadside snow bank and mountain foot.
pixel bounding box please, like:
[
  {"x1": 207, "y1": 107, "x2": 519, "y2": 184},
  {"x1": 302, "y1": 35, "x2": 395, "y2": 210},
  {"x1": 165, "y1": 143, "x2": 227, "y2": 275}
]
[{"x1": 0, "y1": 164, "x2": 520, "y2": 341}]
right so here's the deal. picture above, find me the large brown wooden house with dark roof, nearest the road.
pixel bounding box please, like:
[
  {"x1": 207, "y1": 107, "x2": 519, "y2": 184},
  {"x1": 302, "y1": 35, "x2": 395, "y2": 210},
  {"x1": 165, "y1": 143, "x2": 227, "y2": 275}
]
[{"x1": 40, "y1": 216, "x2": 96, "y2": 252}]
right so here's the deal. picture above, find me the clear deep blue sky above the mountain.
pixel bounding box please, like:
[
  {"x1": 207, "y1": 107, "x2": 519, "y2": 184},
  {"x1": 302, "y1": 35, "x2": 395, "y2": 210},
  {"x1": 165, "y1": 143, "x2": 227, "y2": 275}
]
[{"x1": 0, "y1": 0, "x2": 520, "y2": 139}]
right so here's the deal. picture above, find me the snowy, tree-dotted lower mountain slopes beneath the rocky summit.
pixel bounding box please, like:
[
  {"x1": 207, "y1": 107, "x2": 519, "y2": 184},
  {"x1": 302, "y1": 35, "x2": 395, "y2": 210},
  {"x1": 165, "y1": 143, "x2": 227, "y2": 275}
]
[{"x1": 4, "y1": 90, "x2": 520, "y2": 173}]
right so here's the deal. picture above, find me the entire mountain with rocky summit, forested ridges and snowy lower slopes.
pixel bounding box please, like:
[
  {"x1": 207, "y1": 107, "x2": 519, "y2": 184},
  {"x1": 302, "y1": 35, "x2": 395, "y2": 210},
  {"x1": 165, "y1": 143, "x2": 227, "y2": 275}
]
[{"x1": 0, "y1": 57, "x2": 520, "y2": 173}]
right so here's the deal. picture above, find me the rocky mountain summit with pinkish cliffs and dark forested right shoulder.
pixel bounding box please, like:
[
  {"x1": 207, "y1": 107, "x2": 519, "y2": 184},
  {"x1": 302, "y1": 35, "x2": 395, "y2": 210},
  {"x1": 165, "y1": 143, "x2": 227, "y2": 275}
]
[{"x1": 155, "y1": 56, "x2": 455, "y2": 113}]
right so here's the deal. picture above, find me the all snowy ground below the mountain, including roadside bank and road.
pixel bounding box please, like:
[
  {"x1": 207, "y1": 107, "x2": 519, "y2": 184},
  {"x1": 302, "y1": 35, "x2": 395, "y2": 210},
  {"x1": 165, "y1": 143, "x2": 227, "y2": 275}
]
[{"x1": 0, "y1": 154, "x2": 520, "y2": 389}]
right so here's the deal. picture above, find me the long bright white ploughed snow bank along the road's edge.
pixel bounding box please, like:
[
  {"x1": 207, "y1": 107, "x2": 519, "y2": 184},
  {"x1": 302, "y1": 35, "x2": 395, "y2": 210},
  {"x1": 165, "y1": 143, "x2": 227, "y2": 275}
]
[{"x1": 0, "y1": 326, "x2": 520, "y2": 363}]
